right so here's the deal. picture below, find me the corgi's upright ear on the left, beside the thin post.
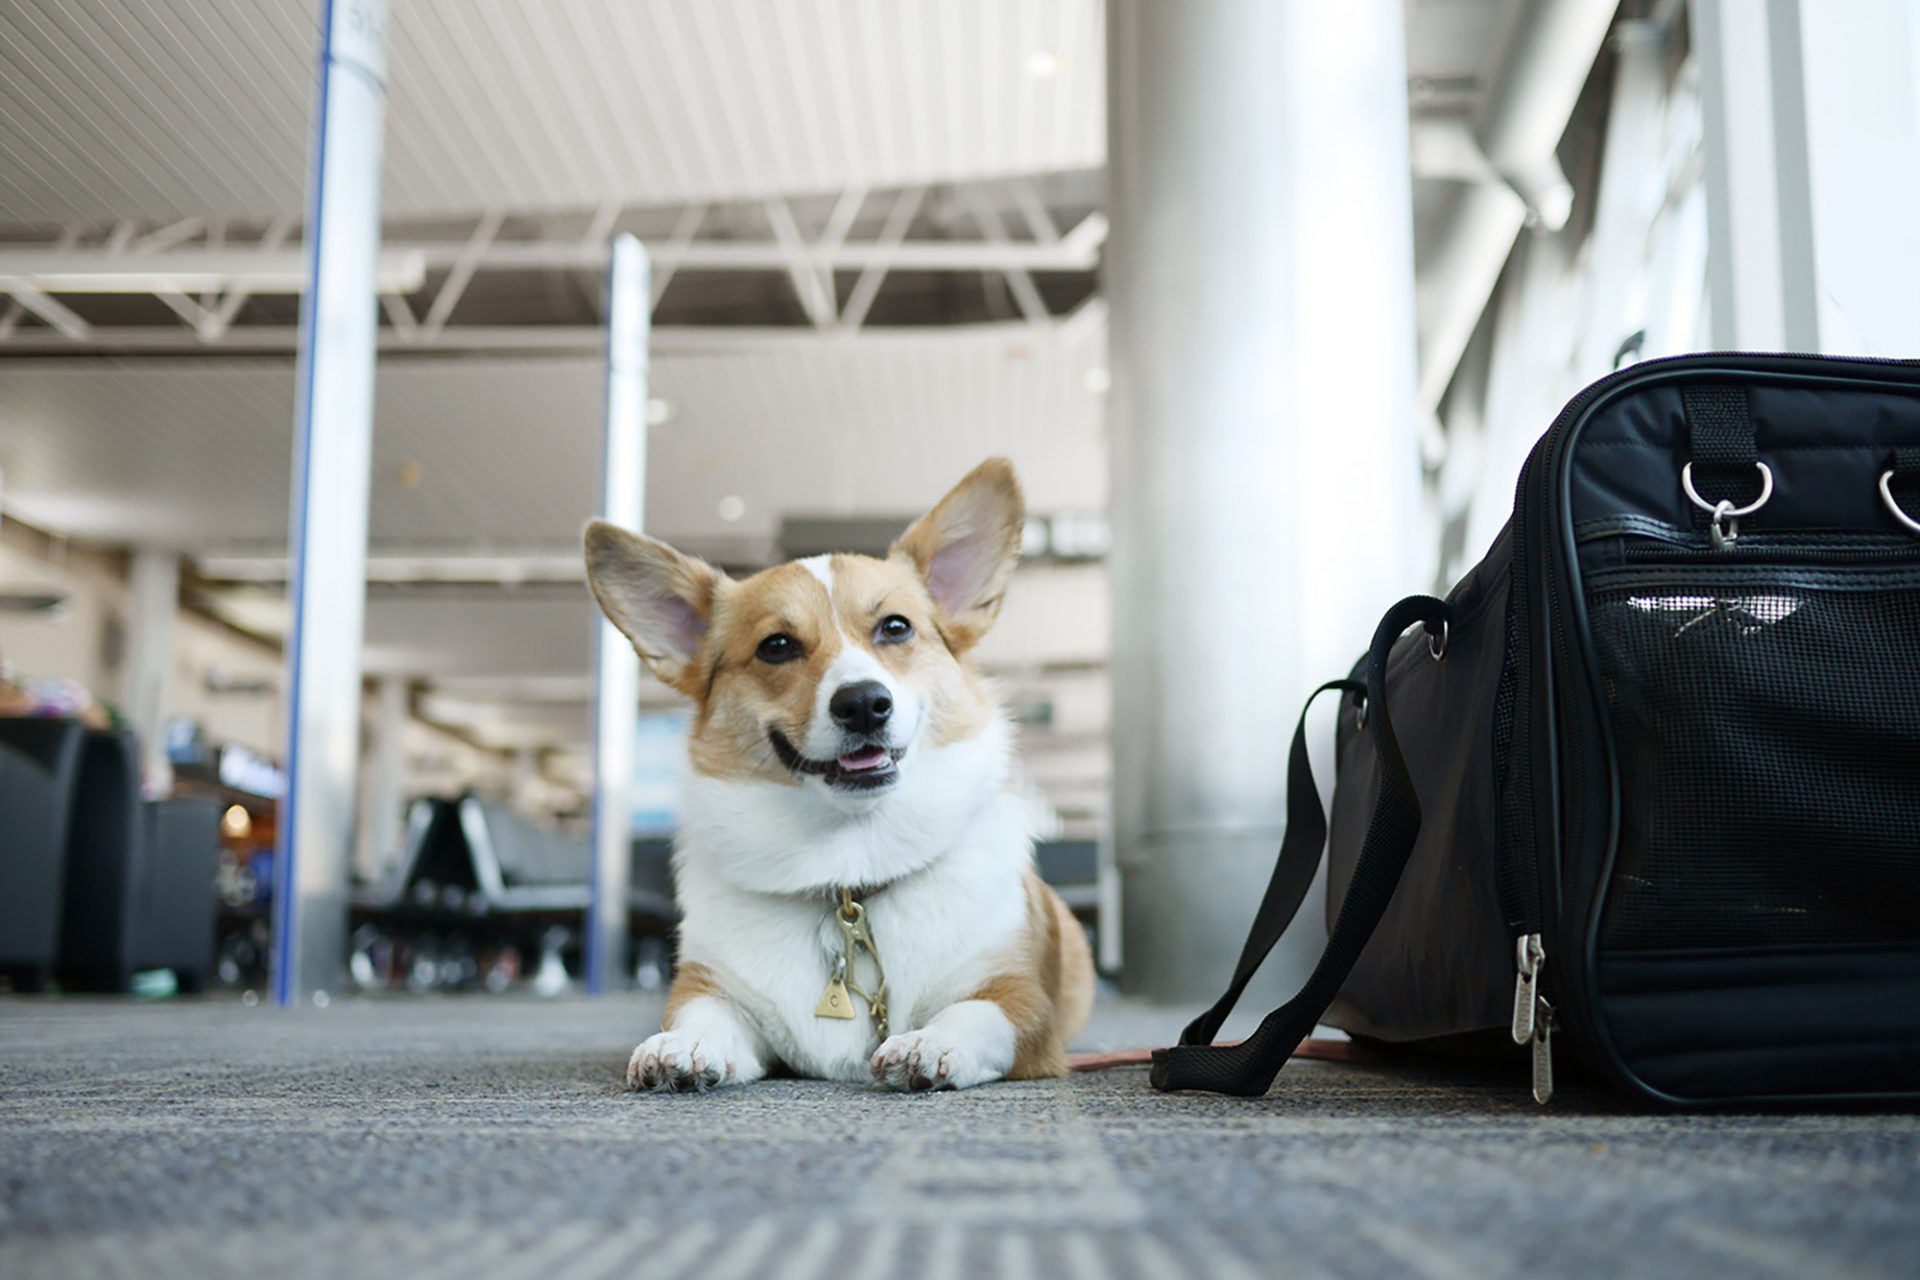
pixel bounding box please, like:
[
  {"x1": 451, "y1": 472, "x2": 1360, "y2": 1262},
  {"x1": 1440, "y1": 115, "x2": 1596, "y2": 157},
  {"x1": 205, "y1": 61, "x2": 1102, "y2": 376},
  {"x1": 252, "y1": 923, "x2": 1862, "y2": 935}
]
[{"x1": 586, "y1": 520, "x2": 726, "y2": 697}]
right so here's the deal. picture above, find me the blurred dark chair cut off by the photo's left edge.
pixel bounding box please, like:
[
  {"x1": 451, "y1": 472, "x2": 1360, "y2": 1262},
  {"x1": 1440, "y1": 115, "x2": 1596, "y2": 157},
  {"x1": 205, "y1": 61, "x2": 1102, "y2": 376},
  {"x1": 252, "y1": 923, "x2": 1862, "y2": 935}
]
[{"x1": 0, "y1": 720, "x2": 83, "y2": 990}]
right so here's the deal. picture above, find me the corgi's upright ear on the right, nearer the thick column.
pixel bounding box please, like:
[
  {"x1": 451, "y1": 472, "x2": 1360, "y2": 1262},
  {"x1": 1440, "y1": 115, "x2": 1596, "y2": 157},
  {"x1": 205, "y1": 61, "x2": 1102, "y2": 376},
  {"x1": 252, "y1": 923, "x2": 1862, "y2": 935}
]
[{"x1": 891, "y1": 459, "x2": 1027, "y2": 652}]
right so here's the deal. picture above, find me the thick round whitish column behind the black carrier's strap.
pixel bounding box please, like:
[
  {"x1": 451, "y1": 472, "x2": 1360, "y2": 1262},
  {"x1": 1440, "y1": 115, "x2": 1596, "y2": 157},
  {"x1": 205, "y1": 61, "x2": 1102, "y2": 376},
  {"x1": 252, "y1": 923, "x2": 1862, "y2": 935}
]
[{"x1": 1106, "y1": 0, "x2": 1430, "y2": 1007}]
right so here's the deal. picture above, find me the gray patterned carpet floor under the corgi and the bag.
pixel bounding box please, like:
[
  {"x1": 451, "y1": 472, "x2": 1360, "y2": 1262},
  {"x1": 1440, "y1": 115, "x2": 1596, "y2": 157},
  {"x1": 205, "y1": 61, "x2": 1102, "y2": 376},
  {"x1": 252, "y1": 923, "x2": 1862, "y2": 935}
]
[{"x1": 0, "y1": 998, "x2": 1920, "y2": 1280}]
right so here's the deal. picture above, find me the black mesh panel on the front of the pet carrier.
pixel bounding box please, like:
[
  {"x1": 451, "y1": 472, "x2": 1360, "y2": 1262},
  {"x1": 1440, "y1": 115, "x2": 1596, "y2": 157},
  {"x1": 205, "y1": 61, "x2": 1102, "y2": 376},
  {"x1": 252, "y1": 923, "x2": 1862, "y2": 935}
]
[{"x1": 1588, "y1": 568, "x2": 1920, "y2": 950}]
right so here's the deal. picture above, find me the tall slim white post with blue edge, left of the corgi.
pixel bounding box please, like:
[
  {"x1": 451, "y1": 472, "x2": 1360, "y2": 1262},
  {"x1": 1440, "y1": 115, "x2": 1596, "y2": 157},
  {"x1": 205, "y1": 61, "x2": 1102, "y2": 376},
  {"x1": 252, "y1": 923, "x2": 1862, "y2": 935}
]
[{"x1": 273, "y1": 0, "x2": 386, "y2": 1006}]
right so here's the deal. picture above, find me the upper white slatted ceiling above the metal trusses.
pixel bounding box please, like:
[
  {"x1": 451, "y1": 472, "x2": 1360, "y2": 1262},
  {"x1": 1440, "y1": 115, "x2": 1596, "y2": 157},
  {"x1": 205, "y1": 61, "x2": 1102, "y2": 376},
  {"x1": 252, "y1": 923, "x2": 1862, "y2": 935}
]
[{"x1": 0, "y1": 0, "x2": 1106, "y2": 225}]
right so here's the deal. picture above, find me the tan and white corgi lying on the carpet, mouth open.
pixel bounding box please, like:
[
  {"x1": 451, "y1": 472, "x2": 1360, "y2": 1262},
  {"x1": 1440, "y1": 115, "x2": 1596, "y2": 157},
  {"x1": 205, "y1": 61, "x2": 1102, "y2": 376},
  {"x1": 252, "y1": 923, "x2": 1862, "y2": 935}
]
[{"x1": 586, "y1": 459, "x2": 1094, "y2": 1090}]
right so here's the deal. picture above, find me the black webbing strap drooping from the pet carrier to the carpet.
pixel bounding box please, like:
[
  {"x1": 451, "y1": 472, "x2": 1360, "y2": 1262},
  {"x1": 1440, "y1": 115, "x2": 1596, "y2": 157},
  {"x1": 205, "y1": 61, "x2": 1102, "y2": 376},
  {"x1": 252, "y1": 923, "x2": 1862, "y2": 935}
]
[{"x1": 1148, "y1": 595, "x2": 1453, "y2": 1098}]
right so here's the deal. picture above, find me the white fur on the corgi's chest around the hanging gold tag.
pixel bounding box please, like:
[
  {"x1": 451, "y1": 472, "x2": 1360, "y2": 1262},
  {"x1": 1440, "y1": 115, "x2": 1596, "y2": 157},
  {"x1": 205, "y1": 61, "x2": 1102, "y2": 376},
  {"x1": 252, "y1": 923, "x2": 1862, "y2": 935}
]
[{"x1": 676, "y1": 756, "x2": 1031, "y2": 1080}]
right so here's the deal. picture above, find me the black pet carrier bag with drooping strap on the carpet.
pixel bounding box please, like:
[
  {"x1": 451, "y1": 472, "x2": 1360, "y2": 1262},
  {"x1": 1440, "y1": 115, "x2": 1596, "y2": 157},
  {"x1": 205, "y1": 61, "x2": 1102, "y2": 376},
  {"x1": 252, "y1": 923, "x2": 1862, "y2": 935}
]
[{"x1": 1152, "y1": 355, "x2": 1920, "y2": 1105}]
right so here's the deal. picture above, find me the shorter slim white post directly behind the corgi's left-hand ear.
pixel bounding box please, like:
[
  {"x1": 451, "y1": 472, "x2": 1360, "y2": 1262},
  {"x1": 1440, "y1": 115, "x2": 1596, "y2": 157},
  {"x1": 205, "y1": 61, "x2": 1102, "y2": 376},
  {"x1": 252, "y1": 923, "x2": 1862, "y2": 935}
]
[{"x1": 586, "y1": 236, "x2": 653, "y2": 996}]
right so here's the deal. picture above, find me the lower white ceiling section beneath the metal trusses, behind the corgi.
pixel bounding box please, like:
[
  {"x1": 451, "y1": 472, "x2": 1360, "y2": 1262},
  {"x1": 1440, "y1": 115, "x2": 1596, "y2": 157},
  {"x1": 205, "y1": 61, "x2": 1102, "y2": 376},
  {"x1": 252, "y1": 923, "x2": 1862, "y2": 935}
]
[{"x1": 0, "y1": 324, "x2": 1106, "y2": 555}]
